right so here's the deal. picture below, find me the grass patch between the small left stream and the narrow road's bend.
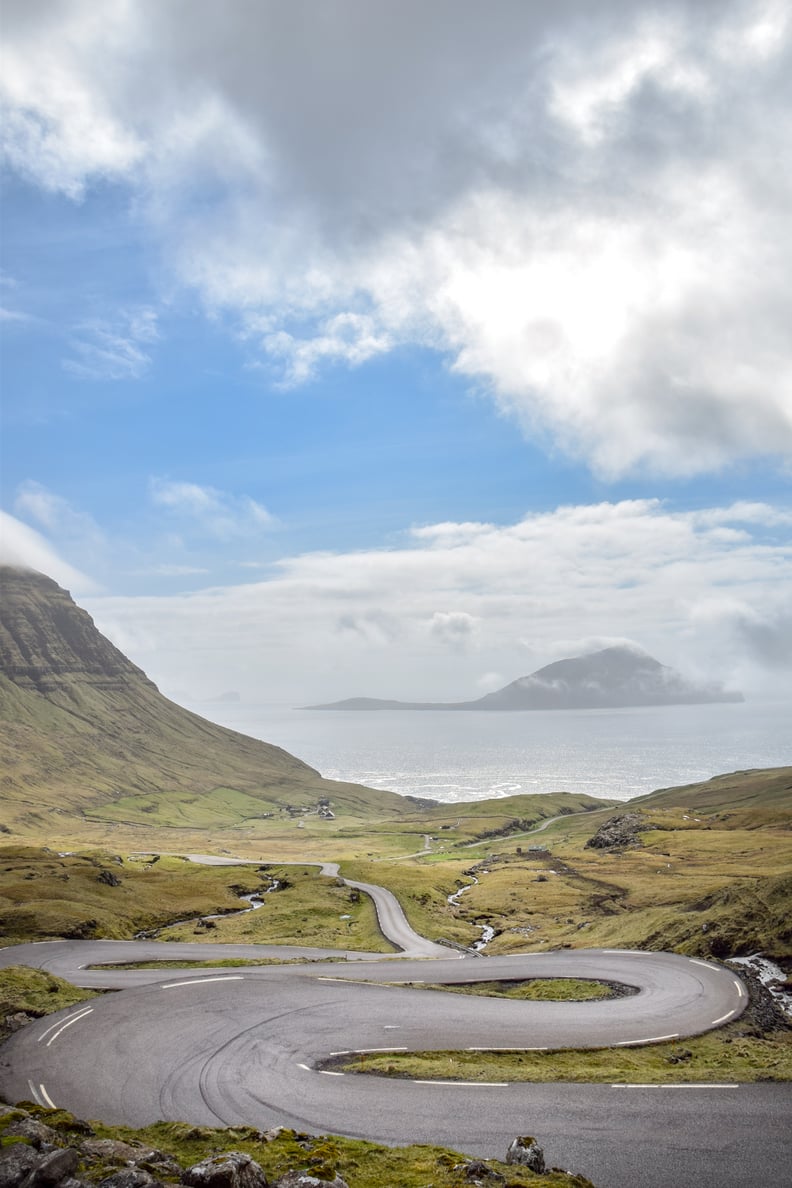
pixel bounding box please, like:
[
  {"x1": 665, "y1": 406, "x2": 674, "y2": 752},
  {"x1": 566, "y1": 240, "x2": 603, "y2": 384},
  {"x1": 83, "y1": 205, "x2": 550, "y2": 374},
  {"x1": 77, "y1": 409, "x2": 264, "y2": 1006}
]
[{"x1": 158, "y1": 866, "x2": 393, "y2": 953}]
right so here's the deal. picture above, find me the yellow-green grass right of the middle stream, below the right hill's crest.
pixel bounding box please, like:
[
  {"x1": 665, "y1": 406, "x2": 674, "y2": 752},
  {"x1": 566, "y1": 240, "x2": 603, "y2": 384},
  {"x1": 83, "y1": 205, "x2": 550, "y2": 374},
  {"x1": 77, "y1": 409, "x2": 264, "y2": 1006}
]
[{"x1": 425, "y1": 807, "x2": 792, "y2": 959}]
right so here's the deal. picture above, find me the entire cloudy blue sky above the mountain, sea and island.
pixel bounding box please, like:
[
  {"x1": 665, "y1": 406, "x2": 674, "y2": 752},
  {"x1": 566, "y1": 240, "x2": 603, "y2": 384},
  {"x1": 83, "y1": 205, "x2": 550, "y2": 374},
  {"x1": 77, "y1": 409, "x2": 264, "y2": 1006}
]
[{"x1": 0, "y1": 0, "x2": 792, "y2": 714}]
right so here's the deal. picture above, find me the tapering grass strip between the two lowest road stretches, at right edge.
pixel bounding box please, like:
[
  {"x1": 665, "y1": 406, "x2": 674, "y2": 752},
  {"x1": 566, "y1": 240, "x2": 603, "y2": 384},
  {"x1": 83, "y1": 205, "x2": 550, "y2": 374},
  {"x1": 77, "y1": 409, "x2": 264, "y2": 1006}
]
[{"x1": 325, "y1": 1022, "x2": 792, "y2": 1085}]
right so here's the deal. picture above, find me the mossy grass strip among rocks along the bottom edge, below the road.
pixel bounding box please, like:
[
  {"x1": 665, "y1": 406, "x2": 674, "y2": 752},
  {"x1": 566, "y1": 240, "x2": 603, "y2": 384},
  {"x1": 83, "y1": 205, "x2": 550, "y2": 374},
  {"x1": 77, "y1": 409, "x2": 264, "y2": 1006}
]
[{"x1": 0, "y1": 1101, "x2": 593, "y2": 1188}]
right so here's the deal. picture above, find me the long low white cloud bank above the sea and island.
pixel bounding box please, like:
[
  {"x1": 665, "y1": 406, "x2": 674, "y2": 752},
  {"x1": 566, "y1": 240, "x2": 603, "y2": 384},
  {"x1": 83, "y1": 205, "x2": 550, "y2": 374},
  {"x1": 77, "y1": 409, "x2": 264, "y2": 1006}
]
[{"x1": 78, "y1": 500, "x2": 792, "y2": 704}]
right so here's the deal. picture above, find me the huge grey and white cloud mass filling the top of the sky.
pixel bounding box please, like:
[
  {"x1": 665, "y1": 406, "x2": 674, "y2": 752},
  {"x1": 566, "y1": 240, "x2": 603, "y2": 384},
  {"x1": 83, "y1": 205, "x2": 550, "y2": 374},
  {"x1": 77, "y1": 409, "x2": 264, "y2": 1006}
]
[{"x1": 2, "y1": 0, "x2": 792, "y2": 476}]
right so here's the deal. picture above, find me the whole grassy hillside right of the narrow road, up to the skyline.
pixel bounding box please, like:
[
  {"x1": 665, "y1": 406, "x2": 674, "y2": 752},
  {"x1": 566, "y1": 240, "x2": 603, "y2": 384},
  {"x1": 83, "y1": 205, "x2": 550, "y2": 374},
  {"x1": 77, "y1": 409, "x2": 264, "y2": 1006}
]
[{"x1": 344, "y1": 769, "x2": 792, "y2": 960}]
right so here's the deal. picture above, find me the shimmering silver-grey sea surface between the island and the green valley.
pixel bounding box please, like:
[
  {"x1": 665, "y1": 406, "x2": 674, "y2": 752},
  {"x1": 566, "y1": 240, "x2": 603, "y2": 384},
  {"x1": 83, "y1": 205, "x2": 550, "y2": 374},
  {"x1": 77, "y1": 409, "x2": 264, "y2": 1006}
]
[{"x1": 190, "y1": 701, "x2": 792, "y2": 803}]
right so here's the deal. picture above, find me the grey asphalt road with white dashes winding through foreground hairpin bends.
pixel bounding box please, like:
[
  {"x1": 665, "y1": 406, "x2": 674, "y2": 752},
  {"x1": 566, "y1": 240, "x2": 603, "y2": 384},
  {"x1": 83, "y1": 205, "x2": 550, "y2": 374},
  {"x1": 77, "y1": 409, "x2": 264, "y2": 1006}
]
[{"x1": 0, "y1": 872, "x2": 792, "y2": 1188}]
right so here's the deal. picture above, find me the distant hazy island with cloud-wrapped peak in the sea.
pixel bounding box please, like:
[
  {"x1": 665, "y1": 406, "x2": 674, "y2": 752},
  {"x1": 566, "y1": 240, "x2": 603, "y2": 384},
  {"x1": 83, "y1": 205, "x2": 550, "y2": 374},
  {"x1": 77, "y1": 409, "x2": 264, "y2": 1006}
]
[{"x1": 302, "y1": 645, "x2": 745, "y2": 710}]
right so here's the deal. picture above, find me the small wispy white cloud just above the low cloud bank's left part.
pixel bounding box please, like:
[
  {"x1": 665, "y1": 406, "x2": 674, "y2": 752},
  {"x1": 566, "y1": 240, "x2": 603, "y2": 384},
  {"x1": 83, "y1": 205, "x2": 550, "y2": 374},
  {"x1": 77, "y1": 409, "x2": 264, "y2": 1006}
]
[{"x1": 148, "y1": 479, "x2": 275, "y2": 541}]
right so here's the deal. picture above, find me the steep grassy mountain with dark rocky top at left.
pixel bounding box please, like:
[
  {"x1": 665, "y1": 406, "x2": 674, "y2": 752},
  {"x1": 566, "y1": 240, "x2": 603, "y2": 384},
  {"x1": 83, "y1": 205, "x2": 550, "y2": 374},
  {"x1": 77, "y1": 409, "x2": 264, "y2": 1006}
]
[{"x1": 0, "y1": 565, "x2": 414, "y2": 836}]
